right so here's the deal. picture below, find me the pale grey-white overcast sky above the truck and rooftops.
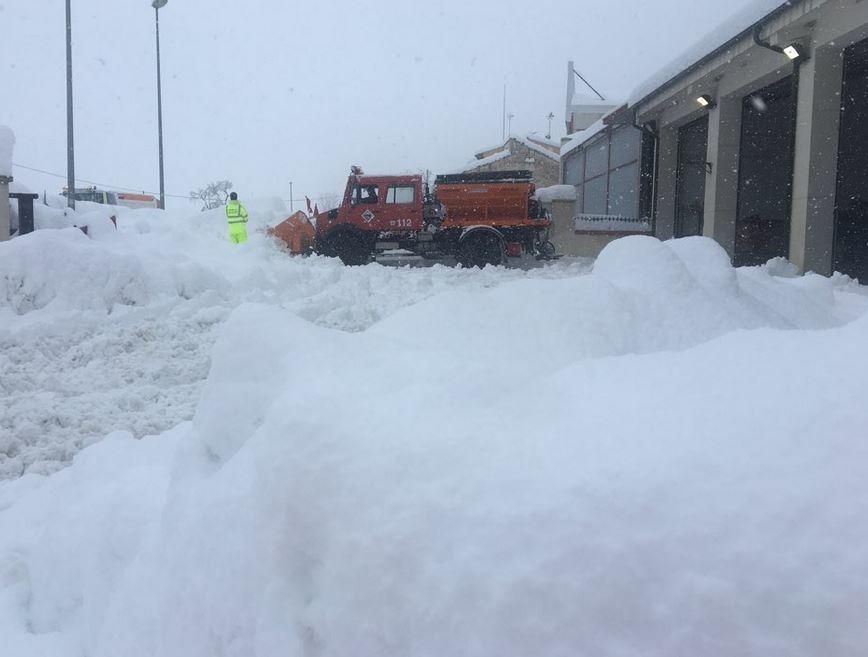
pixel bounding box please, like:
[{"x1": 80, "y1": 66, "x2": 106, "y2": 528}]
[{"x1": 0, "y1": 0, "x2": 752, "y2": 207}]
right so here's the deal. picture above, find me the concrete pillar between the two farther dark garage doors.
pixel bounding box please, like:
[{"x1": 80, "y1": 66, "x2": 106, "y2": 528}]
[{"x1": 703, "y1": 95, "x2": 742, "y2": 258}]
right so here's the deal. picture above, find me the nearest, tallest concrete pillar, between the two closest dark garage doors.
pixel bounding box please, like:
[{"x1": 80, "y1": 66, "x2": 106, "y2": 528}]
[{"x1": 790, "y1": 47, "x2": 843, "y2": 275}]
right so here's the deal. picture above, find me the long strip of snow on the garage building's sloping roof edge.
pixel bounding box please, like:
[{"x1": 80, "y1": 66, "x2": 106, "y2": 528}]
[{"x1": 628, "y1": 0, "x2": 801, "y2": 106}]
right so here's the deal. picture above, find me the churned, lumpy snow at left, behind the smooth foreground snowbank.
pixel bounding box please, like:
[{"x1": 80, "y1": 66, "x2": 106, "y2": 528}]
[{"x1": 0, "y1": 205, "x2": 589, "y2": 479}]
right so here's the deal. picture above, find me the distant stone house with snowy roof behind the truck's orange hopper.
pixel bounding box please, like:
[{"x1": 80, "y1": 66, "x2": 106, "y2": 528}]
[{"x1": 460, "y1": 135, "x2": 560, "y2": 187}]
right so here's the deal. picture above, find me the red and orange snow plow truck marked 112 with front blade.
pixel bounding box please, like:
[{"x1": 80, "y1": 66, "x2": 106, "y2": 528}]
[{"x1": 271, "y1": 167, "x2": 555, "y2": 267}]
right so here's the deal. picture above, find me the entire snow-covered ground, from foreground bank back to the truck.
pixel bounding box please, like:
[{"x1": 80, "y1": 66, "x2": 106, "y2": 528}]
[{"x1": 0, "y1": 203, "x2": 868, "y2": 657}]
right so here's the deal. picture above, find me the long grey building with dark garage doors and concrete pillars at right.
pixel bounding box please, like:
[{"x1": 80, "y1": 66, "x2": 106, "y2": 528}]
[{"x1": 562, "y1": 0, "x2": 868, "y2": 280}]
